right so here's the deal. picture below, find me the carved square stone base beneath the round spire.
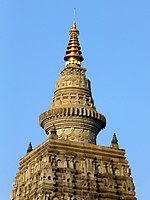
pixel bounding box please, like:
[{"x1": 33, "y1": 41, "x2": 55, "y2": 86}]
[{"x1": 10, "y1": 138, "x2": 136, "y2": 200}]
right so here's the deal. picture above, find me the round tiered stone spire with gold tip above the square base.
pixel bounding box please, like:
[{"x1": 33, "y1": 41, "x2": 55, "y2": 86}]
[{"x1": 40, "y1": 22, "x2": 106, "y2": 144}]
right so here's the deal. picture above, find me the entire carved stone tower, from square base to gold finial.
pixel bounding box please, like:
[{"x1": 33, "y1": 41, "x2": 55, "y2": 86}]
[{"x1": 10, "y1": 21, "x2": 136, "y2": 200}]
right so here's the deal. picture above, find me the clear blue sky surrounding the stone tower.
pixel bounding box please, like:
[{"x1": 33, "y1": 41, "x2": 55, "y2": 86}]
[{"x1": 0, "y1": 0, "x2": 150, "y2": 200}]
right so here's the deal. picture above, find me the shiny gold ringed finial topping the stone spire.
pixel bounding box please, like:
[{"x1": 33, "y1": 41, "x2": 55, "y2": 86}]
[{"x1": 64, "y1": 19, "x2": 83, "y2": 64}]
